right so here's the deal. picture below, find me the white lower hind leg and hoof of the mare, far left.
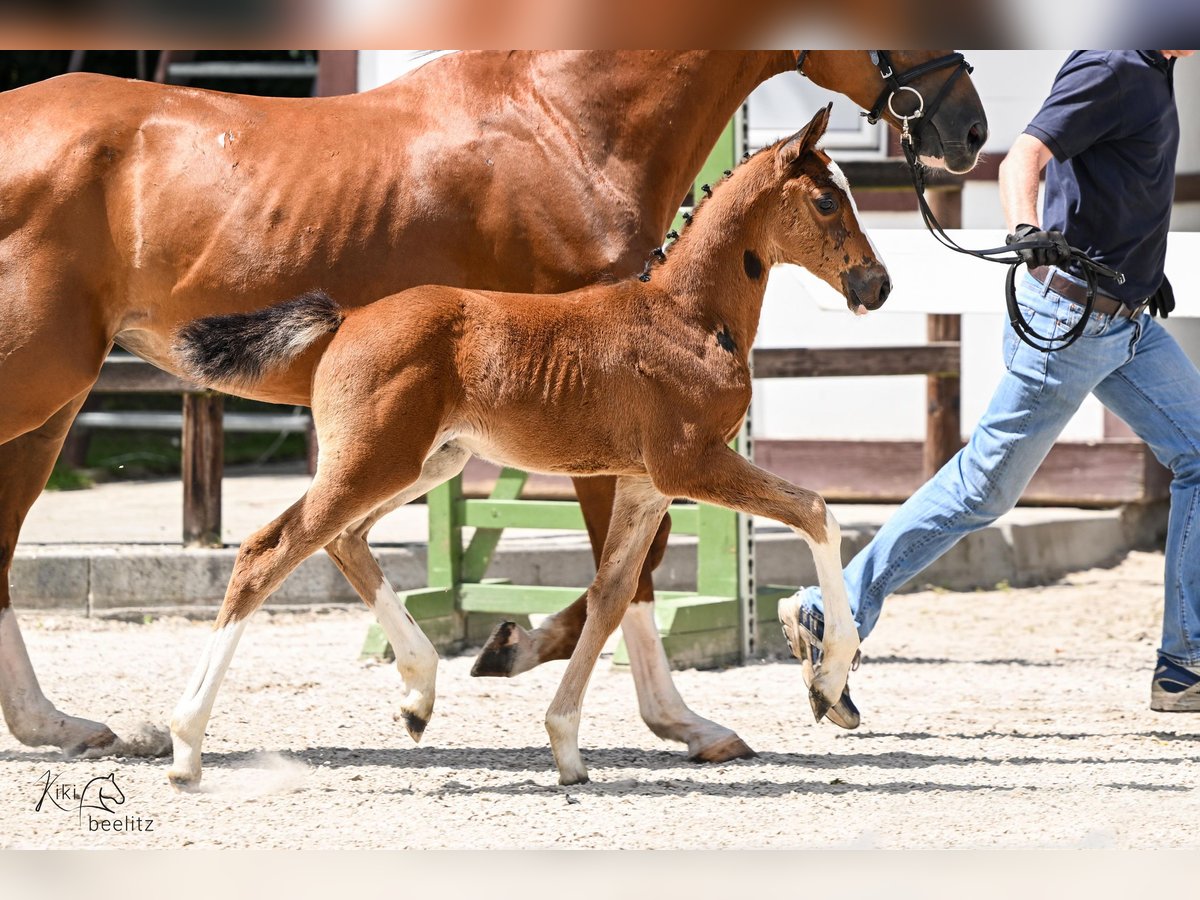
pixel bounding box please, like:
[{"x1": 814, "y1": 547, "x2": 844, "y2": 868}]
[{"x1": 0, "y1": 606, "x2": 116, "y2": 756}]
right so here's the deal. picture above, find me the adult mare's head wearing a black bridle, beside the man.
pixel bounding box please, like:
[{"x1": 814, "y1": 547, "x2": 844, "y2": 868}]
[{"x1": 800, "y1": 50, "x2": 988, "y2": 173}]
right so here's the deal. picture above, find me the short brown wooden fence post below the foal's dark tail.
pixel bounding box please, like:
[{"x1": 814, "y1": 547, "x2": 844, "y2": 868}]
[{"x1": 182, "y1": 394, "x2": 224, "y2": 547}]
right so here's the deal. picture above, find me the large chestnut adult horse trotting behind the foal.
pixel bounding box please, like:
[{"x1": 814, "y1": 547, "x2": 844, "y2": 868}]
[{"x1": 0, "y1": 50, "x2": 985, "y2": 758}]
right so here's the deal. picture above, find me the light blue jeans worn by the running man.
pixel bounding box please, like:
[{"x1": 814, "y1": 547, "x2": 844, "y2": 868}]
[{"x1": 802, "y1": 267, "x2": 1200, "y2": 666}]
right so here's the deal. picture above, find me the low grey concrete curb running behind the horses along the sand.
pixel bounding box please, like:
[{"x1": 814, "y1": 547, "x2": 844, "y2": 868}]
[{"x1": 11, "y1": 504, "x2": 1166, "y2": 616}]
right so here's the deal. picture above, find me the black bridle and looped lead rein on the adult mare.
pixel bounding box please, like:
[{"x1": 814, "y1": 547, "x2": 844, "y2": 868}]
[{"x1": 796, "y1": 50, "x2": 1124, "y2": 353}]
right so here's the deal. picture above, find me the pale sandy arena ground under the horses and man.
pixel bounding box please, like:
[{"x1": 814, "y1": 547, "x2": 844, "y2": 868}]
[{"x1": 0, "y1": 553, "x2": 1200, "y2": 848}]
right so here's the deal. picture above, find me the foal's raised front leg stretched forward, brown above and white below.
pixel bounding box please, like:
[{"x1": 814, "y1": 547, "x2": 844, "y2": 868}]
[{"x1": 650, "y1": 444, "x2": 858, "y2": 721}]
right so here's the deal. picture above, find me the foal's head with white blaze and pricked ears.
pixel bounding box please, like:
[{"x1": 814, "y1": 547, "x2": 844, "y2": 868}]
[{"x1": 746, "y1": 104, "x2": 892, "y2": 316}]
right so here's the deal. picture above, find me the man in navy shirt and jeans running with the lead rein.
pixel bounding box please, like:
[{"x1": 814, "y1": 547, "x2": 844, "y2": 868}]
[{"x1": 779, "y1": 50, "x2": 1200, "y2": 728}]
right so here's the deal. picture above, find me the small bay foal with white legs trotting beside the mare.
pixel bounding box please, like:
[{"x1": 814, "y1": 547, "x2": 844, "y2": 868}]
[{"x1": 169, "y1": 108, "x2": 890, "y2": 787}]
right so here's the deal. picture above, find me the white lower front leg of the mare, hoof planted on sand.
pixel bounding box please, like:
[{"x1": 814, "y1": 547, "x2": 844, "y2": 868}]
[{"x1": 620, "y1": 604, "x2": 754, "y2": 762}]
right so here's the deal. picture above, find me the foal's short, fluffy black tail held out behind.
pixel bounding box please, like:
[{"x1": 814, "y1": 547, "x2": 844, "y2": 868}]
[{"x1": 174, "y1": 290, "x2": 346, "y2": 384}]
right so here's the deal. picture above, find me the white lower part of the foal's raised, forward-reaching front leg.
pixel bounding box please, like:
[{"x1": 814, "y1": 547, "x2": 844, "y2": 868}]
[{"x1": 797, "y1": 506, "x2": 858, "y2": 720}]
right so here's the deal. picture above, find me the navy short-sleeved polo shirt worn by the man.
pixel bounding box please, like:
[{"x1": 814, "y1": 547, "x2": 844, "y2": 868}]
[{"x1": 1025, "y1": 50, "x2": 1180, "y2": 305}]
